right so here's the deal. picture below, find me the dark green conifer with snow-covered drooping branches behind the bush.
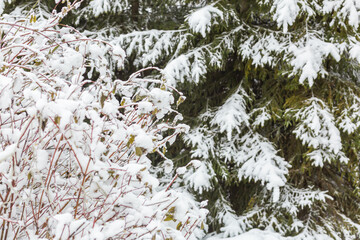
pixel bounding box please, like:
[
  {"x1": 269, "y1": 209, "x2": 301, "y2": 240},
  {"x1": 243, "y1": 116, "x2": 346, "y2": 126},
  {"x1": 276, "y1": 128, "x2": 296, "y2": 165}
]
[{"x1": 5, "y1": 0, "x2": 360, "y2": 239}]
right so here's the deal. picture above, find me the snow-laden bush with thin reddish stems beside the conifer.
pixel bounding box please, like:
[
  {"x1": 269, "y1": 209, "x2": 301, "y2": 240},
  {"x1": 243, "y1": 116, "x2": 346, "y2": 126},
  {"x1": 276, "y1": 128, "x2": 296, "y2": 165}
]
[{"x1": 0, "y1": 1, "x2": 206, "y2": 239}]
